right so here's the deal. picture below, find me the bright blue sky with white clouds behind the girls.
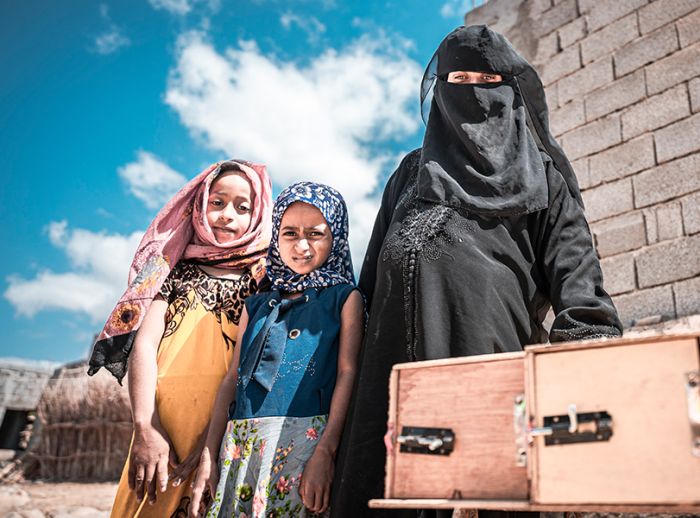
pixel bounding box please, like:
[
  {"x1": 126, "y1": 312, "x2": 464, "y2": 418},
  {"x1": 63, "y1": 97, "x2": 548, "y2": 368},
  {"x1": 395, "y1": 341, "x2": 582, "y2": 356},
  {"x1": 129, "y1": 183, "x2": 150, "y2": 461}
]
[{"x1": 0, "y1": 0, "x2": 478, "y2": 362}]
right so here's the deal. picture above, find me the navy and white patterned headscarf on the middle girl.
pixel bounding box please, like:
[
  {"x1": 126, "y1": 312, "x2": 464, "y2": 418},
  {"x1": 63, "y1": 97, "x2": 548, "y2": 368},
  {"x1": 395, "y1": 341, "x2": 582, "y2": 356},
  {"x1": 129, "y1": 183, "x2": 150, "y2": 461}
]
[{"x1": 267, "y1": 182, "x2": 355, "y2": 292}]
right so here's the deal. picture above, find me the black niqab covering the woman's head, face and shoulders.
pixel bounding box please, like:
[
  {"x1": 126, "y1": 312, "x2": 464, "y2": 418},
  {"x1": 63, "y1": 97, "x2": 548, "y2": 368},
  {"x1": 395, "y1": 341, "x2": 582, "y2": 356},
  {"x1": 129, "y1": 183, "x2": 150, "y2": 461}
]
[{"x1": 417, "y1": 25, "x2": 583, "y2": 216}]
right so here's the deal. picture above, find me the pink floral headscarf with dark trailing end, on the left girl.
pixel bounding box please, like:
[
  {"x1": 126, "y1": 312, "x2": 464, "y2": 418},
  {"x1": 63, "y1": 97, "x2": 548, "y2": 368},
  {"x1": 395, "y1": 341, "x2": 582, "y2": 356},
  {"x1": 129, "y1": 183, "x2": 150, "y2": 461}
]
[{"x1": 88, "y1": 160, "x2": 272, "y2": 381}]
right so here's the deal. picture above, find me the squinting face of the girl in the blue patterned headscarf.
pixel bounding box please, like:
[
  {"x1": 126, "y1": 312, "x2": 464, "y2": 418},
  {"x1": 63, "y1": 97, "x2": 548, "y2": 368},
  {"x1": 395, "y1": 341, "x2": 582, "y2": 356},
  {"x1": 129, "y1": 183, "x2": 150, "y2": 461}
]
[{"x1": 278, "y1": 202, "x2": 333, "y2": 275}]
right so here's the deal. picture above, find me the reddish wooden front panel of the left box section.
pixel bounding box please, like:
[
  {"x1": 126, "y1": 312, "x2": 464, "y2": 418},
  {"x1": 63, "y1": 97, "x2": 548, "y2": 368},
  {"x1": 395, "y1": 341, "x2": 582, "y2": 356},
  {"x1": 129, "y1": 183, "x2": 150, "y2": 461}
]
[{"x1": 387, "y1": 353, "x2": 528, "y2": 500}]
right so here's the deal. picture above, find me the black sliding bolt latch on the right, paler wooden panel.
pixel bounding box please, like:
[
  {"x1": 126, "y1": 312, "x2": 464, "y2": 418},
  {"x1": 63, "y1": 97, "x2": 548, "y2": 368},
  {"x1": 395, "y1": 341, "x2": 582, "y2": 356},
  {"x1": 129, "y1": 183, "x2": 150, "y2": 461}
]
[{"x1": 530, "y1": 404, "x2": 613, "y2": 446}]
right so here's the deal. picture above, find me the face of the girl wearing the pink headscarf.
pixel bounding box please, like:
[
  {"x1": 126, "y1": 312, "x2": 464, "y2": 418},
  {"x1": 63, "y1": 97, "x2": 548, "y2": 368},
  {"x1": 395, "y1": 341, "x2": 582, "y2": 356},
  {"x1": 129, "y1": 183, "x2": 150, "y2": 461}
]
[{"x1": 207, "y1": 171, "x2": 253, "y2": 243}]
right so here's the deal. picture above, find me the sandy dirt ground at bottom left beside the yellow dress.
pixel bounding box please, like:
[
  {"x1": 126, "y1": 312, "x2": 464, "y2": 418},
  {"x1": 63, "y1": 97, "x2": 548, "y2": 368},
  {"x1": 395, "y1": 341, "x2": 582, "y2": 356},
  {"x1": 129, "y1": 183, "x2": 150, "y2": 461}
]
[{"x1": 0, "y1": 482, "x2": 117, "y2": 518}]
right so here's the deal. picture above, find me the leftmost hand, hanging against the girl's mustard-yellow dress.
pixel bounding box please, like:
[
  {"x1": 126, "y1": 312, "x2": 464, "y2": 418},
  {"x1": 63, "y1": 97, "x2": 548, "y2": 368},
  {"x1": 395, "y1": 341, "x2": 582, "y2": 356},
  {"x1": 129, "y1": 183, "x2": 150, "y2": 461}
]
[{"x1": 129, "y1": 424, "x2": 177, "y2": 504}]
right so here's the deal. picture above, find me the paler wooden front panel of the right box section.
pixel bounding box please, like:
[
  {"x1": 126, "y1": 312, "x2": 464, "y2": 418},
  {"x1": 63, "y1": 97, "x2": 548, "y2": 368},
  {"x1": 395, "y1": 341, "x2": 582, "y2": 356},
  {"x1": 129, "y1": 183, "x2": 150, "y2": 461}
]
[{"x1": 528, "y1": 337, "x2": 700, "y2": 507}]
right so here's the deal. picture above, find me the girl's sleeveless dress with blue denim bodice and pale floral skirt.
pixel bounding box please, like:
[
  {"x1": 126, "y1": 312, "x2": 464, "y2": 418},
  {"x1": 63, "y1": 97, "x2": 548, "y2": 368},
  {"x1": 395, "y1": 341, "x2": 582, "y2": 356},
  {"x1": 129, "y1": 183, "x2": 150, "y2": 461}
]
[{"x1": 207, "y1": 284, "x2": 355, "y2": 517}]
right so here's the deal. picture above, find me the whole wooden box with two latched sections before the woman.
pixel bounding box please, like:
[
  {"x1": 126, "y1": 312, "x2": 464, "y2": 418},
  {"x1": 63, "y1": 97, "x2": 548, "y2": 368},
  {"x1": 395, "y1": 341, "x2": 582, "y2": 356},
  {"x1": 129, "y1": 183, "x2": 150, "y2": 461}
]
[{"x1": 370, "y1": 334, "x2": 700, "y2": 512}]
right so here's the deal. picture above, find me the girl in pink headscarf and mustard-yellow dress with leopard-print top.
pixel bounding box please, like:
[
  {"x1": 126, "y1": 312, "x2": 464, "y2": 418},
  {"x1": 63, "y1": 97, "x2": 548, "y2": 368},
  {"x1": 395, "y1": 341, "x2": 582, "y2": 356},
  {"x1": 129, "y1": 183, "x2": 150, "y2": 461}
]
[{"x1": 89, "y1": 160, "x2": 272, "y2": 518}]
